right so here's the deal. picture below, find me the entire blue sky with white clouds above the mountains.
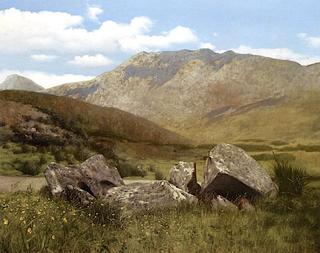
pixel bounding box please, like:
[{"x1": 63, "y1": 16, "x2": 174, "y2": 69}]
[{"x1": 0, "y1": 0, "x2": 320, "y2": 87}]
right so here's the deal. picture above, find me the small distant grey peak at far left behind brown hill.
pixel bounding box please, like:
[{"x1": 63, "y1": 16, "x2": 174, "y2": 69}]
[{"x1": 0, "y1": 74, "x2": 44, "y2": 91}]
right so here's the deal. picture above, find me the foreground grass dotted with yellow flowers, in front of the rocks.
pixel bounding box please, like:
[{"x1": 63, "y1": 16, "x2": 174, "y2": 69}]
[{"x1": 0, "y1": 190, "x2": 320, "y2": 253}]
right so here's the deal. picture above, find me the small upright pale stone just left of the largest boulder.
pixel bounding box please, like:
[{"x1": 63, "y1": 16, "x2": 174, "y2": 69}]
[{"x1": 169, "y1": 162, "x2": 201, "y2": 196}]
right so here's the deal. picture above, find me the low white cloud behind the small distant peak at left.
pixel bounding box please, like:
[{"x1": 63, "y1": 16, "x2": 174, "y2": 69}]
[{"x1": 0, "y1": 70, "x2": 94, "y2": 88}]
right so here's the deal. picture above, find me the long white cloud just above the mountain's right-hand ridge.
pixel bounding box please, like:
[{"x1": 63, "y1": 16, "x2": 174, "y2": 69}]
[{"x1": 220, "y1": 45, "x2": 320, "y2": 65}]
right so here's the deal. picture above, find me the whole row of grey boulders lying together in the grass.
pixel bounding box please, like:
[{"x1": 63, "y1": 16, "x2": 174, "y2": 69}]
[{"x1": 45, "y1": 144, "x2": 277, "y2": 215}]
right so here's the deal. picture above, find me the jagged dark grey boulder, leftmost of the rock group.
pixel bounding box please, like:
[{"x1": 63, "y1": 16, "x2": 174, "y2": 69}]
[{"x1": 44, "y1": 155, "x2": 124, "y2": 201}]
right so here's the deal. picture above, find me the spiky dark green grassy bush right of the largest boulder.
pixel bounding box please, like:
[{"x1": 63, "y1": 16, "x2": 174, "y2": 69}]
[{"x1": 274, "y1": 157, "x2": 309, "y2": 196}]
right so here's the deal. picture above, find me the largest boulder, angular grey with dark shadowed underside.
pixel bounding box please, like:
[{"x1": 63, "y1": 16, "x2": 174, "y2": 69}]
[{"x1": 201, "y1": 144, "x2": 277, "y2": 201}]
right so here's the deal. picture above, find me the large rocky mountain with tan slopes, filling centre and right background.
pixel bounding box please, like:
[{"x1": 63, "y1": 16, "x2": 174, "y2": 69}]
[{"x1": 48, "y1": 49, "x2": 320, "y2": 143}]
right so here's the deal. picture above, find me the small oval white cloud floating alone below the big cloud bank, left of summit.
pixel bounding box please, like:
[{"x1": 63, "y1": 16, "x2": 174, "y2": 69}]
[{"x1": 69, "y1": 54, "x2": 113, "y2": 68}]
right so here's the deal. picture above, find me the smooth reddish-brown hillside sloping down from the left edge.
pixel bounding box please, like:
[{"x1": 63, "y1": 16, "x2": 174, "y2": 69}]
[{"x1": 0, "y1": 91, "x2": 188, "y2": 144}]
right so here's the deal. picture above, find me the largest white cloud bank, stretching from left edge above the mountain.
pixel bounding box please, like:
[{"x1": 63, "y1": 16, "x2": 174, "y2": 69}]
[{"x1": 0, "y1": 8, "x2": 198, "y2": 54}]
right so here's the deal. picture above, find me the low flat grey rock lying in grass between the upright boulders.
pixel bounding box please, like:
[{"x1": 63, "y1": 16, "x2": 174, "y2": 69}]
[{"x1": 103, "y1": 180, "x2": 198, "y2": 216}]
